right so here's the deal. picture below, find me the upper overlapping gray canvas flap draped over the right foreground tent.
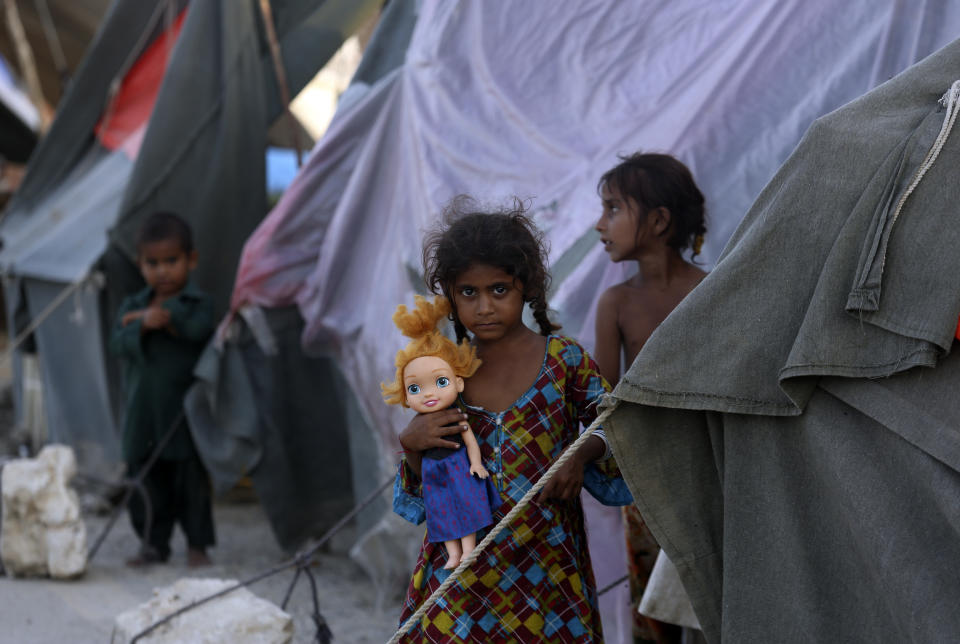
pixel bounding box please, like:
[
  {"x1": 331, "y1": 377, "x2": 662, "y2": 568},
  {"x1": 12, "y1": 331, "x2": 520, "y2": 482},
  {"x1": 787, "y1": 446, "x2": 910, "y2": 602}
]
[{"x1": 608, "y1": 44, "x2": 960, "y2": 414}]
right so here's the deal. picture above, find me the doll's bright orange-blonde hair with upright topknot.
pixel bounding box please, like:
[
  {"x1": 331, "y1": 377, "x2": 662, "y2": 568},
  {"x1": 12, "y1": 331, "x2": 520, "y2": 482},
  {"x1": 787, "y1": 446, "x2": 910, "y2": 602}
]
[{"x1": 380, "y1": 295, "x2": 480, "y2": 407}]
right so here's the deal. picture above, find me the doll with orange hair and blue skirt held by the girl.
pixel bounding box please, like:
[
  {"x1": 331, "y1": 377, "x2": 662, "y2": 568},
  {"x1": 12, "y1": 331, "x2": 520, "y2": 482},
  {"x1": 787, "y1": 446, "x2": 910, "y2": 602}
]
[{"x1": 381, "y1": 295, "x2": 500, "y2": 568}]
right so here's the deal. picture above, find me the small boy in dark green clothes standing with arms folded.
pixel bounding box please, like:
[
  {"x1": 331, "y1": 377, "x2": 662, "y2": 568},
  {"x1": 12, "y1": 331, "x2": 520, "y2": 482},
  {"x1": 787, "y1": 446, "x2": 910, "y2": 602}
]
[{"x1": 110, "y1": 212, "x2": 215, "y2": 567}]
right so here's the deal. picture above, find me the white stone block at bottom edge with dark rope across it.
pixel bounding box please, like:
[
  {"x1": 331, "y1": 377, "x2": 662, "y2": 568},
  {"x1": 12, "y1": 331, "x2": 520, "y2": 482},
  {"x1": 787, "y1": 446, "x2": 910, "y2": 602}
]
[{"x1": 110, "y1": 578, "x2": 293, "y2": 644}]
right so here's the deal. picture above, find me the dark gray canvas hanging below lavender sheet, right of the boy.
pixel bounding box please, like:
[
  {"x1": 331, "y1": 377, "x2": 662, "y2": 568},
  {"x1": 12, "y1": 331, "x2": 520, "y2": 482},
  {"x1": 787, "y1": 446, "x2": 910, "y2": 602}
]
[{"x1": 185, "y1": 307, "x2": 383, "y2": 552}]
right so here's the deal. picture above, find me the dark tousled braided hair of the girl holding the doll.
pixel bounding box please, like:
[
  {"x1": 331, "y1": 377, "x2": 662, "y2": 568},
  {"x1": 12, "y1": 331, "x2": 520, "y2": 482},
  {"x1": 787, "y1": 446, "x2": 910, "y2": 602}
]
[{"x1": 423, "y1": 196, "x2": 560, "y2": 342}]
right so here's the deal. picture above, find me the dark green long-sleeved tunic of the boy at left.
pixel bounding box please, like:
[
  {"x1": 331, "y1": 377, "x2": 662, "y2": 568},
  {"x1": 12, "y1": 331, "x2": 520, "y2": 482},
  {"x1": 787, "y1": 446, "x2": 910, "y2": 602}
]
[{"x1": 110, "y1": 282, "x2": 214, "y2": 466}]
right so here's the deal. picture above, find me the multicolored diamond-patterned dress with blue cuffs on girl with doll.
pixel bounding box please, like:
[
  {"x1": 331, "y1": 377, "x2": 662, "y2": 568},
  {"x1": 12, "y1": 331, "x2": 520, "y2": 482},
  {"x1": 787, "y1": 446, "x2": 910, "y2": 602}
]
[{"x1": 394, "y1": 336, "x2": 632, "y2": 643}]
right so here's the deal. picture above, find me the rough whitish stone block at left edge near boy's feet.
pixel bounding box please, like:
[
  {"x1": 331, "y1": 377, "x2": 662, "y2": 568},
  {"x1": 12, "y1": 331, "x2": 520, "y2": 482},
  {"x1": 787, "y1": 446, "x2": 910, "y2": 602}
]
[{"x1": 0, "y1": 445, "x2": 87, "y2": 579}]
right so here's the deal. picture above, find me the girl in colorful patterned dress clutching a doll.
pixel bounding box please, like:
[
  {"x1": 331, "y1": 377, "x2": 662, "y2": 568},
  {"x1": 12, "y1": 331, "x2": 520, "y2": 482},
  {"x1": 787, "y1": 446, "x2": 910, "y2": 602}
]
[{"x1": 394, "y1": 202, "x2": 631, "y2": 642}]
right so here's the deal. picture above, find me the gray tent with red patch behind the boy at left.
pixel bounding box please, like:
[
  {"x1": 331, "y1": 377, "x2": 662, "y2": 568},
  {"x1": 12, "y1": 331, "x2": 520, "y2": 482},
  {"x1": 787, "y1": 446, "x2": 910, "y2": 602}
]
[{"x1": 0, "y1": 0, "x2": 378, "y2": 484}]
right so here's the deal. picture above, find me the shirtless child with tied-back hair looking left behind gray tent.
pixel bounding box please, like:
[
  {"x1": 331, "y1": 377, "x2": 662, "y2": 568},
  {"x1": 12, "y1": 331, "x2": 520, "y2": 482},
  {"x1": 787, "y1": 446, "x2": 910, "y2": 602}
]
[{"x1": 593, "y1": 153, "x2": 706, "y2": 643}]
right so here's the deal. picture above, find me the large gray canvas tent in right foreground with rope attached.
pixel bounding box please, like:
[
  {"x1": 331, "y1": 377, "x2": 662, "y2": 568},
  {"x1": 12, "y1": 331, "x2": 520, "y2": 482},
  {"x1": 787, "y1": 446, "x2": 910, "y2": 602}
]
[{"x1": 607, "y1": 41, "x2": 960, "y2": 642}]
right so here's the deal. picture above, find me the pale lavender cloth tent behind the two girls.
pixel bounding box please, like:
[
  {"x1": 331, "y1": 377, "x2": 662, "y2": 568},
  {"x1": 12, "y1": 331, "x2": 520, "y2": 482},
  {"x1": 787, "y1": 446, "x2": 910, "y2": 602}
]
[{"x1": 191, "y1": 0, "x2": 960, "y2": 638}]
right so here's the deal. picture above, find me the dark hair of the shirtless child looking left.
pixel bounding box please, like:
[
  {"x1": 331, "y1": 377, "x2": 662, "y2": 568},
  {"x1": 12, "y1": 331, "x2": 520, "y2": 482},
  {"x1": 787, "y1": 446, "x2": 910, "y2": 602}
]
[{"x1": 597, "y1": 152, "x2": 707, "y2": 257}]
